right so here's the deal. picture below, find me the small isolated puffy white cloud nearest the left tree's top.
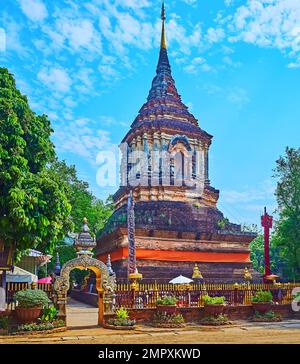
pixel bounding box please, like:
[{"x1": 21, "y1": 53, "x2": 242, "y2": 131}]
[{"x1": 37, "y1": 67, "x2": 72, "y2": 93}]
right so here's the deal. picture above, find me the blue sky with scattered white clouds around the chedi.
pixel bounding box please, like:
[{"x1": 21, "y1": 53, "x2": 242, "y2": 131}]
[{"x1": 0, "y1": 0, "x2": 300, "y2": 228}]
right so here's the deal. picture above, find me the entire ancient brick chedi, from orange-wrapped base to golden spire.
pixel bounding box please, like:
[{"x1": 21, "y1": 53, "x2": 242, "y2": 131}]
[{"x1": 97, "y1": 8, "x2": 255, "y2": 282}]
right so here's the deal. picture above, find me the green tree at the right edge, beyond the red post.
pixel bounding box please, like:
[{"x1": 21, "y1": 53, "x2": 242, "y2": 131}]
[{"x1": 274, "y1": 148, "x2": 300, "y2": 280}]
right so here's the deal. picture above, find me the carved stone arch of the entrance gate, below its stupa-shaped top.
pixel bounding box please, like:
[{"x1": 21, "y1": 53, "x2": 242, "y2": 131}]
[{"x1": 54, "y1": 255, "x2": 116, "y2": 326}]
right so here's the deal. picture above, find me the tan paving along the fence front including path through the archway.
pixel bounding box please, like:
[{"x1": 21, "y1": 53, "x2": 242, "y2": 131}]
[{"x1": 0, "y1": 300, "x2": 300, "y2": 344}]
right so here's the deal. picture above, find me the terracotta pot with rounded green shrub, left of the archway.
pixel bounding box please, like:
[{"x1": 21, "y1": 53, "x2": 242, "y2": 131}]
[{"x1": 15, "y1": 289, "x2": 51, "y2": 323}]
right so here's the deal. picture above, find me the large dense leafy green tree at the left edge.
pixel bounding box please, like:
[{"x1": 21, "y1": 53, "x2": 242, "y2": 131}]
[{"x1": 0, "y1": 68, "x2": 72, "y2": 251}]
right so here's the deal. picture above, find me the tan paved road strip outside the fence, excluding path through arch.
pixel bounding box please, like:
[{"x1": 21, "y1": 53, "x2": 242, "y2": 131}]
[{"x1": 0, "y1": 322, "x2": 300, "y2": 344}]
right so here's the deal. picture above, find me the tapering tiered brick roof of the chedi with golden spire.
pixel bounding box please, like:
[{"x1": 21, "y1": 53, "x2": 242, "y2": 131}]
[{"x1": 123, "y1": 5, "x2": 212, "y2": 142}]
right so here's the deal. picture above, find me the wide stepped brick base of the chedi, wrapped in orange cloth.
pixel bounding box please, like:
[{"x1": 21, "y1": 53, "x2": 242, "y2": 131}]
[{"x1": 97, "y1": 201, "x2": 260, "y2": 283}]
